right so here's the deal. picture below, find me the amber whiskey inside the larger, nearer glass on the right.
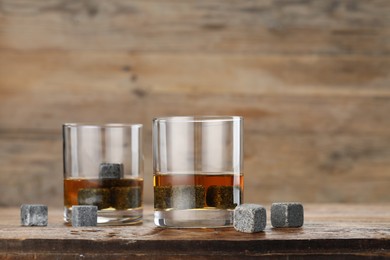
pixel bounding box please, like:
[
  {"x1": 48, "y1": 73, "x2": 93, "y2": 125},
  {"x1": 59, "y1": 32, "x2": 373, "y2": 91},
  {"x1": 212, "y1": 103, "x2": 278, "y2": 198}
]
[{"x1": 154, "y1": 173, "x2": 244, "y2": 210}]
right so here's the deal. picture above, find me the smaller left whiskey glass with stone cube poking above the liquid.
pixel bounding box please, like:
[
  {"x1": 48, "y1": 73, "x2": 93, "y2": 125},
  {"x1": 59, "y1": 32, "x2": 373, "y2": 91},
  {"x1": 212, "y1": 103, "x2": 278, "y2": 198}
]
[{"x1": 62, "y1": 124, "x2": 143, "y2": 225}]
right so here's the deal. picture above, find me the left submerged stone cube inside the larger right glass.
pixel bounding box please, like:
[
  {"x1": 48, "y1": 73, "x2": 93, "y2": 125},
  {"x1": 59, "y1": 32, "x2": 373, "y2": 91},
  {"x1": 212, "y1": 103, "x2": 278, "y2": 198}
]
[{"x1": 171, "y1": 185, "x2": 205, "y2": 209}]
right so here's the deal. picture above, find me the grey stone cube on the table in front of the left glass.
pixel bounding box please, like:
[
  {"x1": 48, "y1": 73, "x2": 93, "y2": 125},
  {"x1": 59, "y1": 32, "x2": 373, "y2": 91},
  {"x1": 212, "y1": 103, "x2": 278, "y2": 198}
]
[{"x1": 72, "y1": 206, "x2": 97, "y2": 227}]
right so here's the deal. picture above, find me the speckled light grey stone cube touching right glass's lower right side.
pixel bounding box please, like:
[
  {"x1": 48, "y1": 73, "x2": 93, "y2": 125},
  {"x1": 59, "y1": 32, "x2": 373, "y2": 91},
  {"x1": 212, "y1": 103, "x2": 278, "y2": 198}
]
[{"x1": 233, "y1": 204, "x2": 267, "y2": 233}]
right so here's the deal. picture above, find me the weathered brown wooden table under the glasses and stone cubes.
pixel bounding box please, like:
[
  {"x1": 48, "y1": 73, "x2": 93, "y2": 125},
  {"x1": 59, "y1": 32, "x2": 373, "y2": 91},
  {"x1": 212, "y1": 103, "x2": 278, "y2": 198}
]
[{"x1": 0, "y1": 204, "x2": 390, "y2": 259}]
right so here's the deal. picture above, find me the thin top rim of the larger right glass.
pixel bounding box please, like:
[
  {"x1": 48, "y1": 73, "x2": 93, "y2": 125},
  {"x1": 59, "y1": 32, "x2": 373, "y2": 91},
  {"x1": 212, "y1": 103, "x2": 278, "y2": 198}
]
[{"x1": 153, "y1": 116, "x2": 243, "y2": 123}]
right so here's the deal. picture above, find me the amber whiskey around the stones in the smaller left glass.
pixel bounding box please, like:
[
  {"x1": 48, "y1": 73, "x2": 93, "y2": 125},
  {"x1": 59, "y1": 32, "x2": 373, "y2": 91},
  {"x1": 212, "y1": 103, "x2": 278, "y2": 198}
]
[{"x1": 64, "y1": 178, "x2": 143, "y2": 209}]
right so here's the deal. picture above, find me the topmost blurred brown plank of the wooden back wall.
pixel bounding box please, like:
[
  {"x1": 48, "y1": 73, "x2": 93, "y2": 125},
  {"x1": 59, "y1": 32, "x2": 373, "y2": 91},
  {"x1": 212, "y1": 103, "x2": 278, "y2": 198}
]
[{"x1": 0, "y1": 0, "x2": 390, "y2": 55}]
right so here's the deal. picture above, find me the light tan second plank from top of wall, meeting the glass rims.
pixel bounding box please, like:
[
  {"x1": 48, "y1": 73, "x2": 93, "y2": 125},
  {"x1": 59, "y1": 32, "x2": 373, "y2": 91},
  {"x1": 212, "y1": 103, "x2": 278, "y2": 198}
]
[{"x1": 0, "y1": 51, "x2": 390, "y2": 132}]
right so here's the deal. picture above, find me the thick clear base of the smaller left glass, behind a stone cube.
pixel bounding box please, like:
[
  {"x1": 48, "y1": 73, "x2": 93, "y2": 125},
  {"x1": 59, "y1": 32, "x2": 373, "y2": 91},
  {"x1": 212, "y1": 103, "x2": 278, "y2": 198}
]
[{"x1": 64, "y1": 207, "x2": 143, "y2": 226}]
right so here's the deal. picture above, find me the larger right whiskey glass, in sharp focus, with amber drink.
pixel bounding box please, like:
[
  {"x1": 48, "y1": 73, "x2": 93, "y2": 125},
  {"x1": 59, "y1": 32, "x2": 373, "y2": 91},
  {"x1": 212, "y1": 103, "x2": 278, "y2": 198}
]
[{"x1": 153, "y1": 116, "x2": 244, "y2": 227}]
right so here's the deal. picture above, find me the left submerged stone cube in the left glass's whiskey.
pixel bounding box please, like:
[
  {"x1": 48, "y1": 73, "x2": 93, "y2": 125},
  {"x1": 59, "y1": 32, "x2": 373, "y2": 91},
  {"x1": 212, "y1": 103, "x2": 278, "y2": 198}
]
[{"x1": 77, "y1": 188, "x2": 111, "y2": 209}]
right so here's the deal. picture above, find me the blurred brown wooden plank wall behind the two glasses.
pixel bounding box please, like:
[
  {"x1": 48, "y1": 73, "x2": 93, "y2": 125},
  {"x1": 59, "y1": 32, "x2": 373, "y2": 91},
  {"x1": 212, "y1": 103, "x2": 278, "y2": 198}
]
[{"x1": 0, "y1": 0, "x2": 390, "y2": 206}]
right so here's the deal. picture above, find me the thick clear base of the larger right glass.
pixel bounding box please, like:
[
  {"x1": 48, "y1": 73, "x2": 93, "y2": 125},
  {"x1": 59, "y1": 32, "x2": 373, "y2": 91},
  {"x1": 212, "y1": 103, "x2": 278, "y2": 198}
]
[{"x1": 154, "y1": 208, "x2": 233, "y2": 228}]
